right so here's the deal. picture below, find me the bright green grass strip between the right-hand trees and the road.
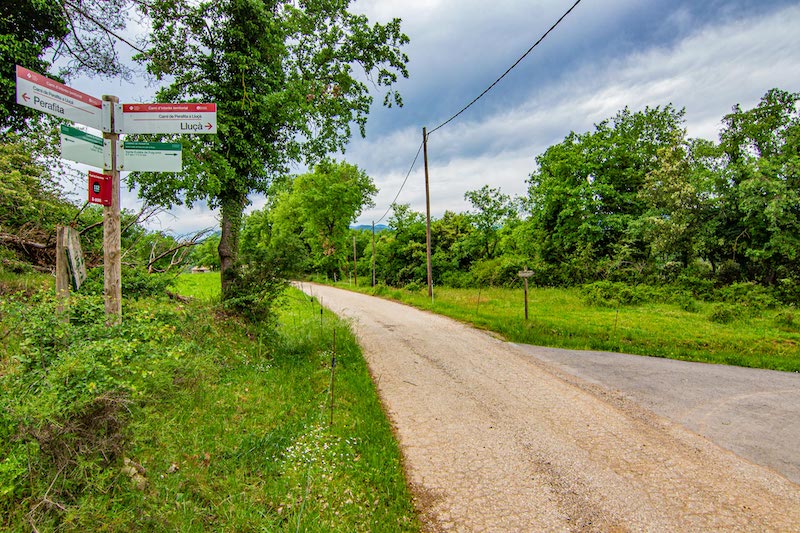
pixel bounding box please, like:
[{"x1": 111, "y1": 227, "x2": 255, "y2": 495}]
[{"x1": 338, "y1": 283, "x2": 800, "y2": 372}]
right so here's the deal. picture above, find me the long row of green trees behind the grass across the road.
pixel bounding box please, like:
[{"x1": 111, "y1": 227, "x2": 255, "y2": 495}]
[{"x1": 242, "y1": 89, "x2": 800, "y2": 301}]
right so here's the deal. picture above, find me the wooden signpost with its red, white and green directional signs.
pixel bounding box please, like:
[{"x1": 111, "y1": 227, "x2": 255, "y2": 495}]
[{"x1": 16, "y1": 65, "x2": 217, "y2": 325}]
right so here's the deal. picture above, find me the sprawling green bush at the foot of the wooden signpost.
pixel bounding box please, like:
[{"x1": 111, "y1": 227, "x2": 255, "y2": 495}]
[{"x1": 0, "y1": 290, "x2": 214, "y2": 520}]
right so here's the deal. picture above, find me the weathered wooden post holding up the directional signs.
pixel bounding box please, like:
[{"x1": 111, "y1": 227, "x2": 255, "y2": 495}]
[{"x1": 103, "y1": 95, "x2": 122, "y2": 326}]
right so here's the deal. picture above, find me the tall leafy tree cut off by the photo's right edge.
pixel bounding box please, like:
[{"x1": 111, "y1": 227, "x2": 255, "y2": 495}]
[{"x1": 715, "y1": 89, "x2": 800, "y2": 284}]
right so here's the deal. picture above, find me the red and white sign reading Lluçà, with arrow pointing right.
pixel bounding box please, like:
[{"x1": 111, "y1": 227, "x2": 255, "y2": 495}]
[{"x1": 114, "y1": 103, "x2": 217, "y2": 133}]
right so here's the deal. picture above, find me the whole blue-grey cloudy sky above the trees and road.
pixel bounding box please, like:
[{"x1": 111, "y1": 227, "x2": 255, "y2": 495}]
[{"x1": 65, "y1": 0, "x2": 800, "y2": 233}]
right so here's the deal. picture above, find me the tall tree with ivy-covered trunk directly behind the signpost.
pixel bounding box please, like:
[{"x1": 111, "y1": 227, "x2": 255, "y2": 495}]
[{"x1": 137, "y1": 0, "x2": 408, "y2": 294}]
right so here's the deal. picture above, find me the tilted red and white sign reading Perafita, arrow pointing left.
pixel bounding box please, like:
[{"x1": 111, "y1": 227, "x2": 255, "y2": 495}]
[{"x1": 17, "y1": 65, "x2": 111, "y2": 131}]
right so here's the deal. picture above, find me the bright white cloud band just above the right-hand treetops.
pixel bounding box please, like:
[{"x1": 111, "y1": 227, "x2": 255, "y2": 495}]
[{"x1": 348, "y1": 1, "x2": 800, "y2": 223}]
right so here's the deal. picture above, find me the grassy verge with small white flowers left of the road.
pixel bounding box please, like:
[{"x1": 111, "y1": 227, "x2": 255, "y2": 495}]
[{"x1": 0, "y1": 274, "x2": 419, "y2": 532}]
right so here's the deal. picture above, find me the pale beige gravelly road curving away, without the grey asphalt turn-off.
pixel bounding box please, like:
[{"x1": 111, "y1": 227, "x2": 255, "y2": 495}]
[{"x1": 303, "y1": 284, "x2": 800, "y2": 531}]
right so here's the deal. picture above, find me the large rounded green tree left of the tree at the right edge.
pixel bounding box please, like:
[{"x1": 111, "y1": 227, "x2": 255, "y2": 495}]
[{"x1": 528, "y1": 105, "x2": 685, "y2": 276}]
